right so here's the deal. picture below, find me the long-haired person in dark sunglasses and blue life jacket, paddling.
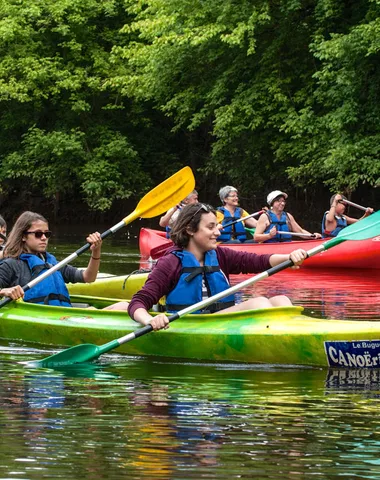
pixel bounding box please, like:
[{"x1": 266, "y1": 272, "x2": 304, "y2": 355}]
[{"x1": 0, "y1": 212, "x2": 102, "y2": 306}]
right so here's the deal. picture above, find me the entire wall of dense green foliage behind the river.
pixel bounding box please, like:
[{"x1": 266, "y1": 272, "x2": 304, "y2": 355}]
[{"x1": 0, "y1": 0, "x2": 380, "y2": 218}]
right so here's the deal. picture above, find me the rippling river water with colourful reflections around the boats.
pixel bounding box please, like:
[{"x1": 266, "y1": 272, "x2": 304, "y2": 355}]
[{"x1": 0, "y1": 226, "x2": 380, "y2": 480}]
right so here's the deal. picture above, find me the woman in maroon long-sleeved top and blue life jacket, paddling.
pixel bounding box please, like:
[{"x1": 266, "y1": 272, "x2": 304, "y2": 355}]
[{"x1": 128, "y1": 203, "x2": 306, "y2": 330}]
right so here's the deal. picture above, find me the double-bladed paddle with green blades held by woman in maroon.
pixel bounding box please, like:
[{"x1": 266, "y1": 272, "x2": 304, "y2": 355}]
[{"x1": 28, "y1": 211, "x2": 380, "y2": 368}]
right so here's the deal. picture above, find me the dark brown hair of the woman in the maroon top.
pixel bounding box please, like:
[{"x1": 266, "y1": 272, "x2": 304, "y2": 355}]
[{"x1": 170, "y1": 203, "x2": 216, "y2": 248}]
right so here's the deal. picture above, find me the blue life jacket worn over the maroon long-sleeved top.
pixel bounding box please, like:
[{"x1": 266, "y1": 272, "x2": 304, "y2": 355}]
[{"x1": 166, "y1": 250, "x2": 235, "y2": 313}]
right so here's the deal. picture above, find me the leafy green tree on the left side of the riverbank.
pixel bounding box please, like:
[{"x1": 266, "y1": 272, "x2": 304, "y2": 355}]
[{"x1": 0, "y1": 0, "x2": 175, "y2": 213}]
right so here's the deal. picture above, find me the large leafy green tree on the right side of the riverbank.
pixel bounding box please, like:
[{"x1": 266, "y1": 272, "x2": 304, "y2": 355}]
[{"x1": 111, "y1": 0, "x2": 380, "y2": 197}]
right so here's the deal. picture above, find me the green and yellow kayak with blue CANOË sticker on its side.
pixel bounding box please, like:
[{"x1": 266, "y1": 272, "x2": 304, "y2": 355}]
[{"x1": 0, "y1": 296, "x2": 380, "y2": 368}]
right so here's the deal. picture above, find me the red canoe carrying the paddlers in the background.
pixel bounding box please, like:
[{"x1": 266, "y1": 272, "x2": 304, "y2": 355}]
[{"x1": 139, "y1": 228, "x2": 380, "y2": 269}]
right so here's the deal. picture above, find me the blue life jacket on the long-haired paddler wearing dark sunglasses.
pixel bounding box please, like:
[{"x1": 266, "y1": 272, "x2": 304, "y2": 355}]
[{"x1": 20, "y1": 252, "x2": 71, "y2": 307}]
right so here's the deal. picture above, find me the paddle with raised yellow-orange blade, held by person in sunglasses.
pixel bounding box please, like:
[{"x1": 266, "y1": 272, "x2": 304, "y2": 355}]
[{"x1": 0, "y1": 167, "x2": 195, "y2": 308}]
